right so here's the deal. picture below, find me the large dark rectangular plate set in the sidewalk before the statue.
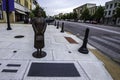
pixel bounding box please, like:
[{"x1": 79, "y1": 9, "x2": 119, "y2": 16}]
[{"x1": 28, "y1": 63, "x2": 80, "y2": 77}]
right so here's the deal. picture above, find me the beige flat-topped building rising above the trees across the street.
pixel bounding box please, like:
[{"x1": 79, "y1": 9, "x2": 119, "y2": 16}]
[{"x1": 73, "y1": 3, "x2": 96, "y2": 19}]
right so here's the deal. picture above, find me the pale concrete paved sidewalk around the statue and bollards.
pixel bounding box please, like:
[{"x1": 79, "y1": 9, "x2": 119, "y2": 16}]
[{"x1": 0, "y1": 24, "x2": 113, "y2": 80}]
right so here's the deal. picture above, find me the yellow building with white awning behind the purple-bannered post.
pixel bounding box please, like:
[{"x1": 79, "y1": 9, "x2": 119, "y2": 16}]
[{"x1": 0, "y1": 0, "x2": 36, "y2": 23}]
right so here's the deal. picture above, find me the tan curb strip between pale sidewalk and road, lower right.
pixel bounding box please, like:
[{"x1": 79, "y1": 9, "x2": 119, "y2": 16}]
[{"x1": 90, "y1": 49, "x2": 120, "y2": 80}]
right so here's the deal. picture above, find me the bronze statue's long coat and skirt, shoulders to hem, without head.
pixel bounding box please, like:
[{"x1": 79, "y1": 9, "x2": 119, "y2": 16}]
[{"x1": 32, "y1": 17, "x2": 46, "y2": 49}]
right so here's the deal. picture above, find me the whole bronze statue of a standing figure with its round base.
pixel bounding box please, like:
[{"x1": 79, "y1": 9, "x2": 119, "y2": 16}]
[{"x1": 32, "y1": 9, "x2": 47, "y2": 58}]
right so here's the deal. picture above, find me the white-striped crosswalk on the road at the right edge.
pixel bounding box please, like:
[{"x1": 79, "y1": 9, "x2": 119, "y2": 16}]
[{"x1": 88, "y1": 36, "x2": 120, "y2": 62}]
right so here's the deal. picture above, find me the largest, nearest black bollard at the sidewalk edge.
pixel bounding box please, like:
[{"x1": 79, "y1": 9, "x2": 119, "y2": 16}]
[{"x1": 78, "y1": 28, "x2": 89, "y2": 54}]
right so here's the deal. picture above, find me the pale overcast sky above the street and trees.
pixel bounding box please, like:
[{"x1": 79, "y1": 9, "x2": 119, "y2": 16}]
[{"x1": 38, "y1": 0, "x2": 110, "y2": 16}]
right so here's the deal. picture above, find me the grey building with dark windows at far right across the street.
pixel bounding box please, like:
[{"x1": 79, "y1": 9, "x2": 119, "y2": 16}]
[{"x1": 104, "y1": 0, "x2": 120, "y2": 25}]
